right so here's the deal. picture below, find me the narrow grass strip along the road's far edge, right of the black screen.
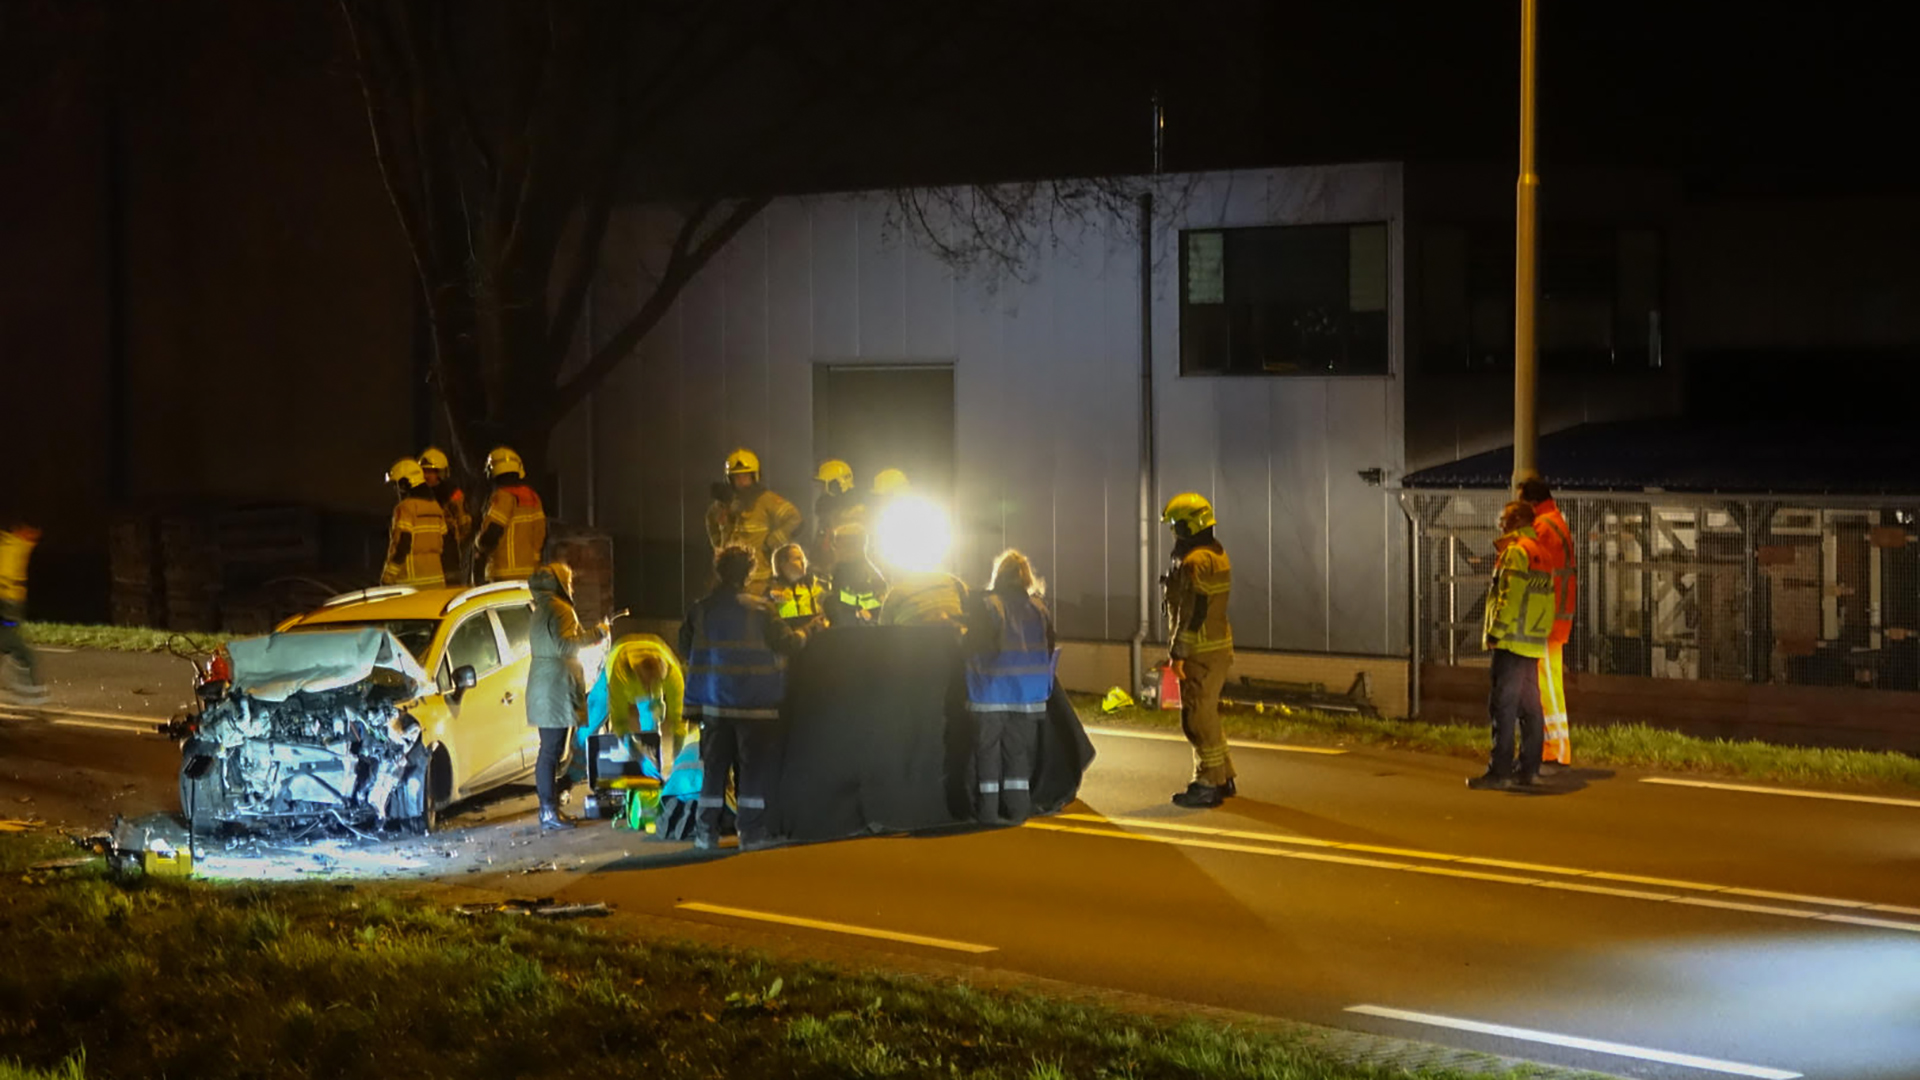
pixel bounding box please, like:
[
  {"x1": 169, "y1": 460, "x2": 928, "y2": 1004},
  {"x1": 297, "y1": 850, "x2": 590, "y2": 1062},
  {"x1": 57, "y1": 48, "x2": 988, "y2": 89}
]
[{"x1": 1073, "y1": 694, "x2": 1920, "y2": 794}]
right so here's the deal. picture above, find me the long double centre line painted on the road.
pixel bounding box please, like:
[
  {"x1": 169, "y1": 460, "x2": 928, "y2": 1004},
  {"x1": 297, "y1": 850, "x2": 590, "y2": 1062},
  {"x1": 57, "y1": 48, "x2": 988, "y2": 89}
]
[{"x1": 1025, "y1": 813, "x2": 1920, "y2": 934}]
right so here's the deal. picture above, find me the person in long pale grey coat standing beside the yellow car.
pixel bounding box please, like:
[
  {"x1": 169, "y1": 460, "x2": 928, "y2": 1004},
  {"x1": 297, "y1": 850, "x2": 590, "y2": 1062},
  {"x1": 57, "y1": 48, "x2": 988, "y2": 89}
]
[{"x1": 526, "y1": 563, "x2": 607, "y2": 832}]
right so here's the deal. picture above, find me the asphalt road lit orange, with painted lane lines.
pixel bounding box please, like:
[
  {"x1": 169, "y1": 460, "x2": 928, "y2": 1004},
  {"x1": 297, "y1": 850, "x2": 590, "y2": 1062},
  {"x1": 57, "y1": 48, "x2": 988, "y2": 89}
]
[{"x1": 0, "y1": 645, "x2": 1920, "y2": 1080}]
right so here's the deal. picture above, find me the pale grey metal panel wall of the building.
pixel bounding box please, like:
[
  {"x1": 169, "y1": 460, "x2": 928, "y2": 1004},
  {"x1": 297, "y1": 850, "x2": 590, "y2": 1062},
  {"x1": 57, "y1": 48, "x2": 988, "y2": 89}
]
[{"x1": 553, "y1": 165, "x2": 1407, "y2": 655}]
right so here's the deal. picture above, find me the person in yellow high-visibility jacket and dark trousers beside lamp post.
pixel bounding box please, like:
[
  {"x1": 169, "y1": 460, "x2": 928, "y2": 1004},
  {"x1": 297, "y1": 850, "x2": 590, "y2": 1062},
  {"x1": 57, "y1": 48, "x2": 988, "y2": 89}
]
[{"x1": 1467, "y1": 502, "x2": 1553, "y2": 792}]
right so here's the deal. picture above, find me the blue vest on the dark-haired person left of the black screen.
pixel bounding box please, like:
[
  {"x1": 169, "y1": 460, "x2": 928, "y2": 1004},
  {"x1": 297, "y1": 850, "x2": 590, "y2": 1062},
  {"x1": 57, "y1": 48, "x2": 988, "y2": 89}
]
[{"x1": 687, "y1": 592, "x2": 787, "y2": 721}]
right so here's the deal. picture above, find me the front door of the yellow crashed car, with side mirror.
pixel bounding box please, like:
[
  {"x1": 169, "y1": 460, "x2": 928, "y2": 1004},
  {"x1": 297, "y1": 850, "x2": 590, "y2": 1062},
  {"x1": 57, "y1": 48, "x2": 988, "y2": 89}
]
[{"x1": 434, "y1": 611, "x2": 526, "y2": 798}]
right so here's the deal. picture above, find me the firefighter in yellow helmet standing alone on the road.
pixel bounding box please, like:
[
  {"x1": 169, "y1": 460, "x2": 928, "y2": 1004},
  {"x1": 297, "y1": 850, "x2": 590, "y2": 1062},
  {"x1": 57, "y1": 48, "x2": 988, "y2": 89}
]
[{"x1": 1160, "y1": 492, "x2": 1236, "y2": 809}]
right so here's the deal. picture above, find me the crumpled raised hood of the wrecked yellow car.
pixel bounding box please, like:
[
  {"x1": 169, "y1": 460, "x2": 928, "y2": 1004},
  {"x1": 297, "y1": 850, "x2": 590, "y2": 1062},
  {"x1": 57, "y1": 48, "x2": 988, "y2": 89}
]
[{"x1": 227, "y1": 626, "x2": 432, "y2": 701}]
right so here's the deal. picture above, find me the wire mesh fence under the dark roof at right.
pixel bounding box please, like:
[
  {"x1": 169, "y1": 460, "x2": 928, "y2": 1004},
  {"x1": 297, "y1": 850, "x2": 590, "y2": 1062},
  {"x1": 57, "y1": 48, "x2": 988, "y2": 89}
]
[{"x1": 1409, "y1": 490, "x2": 1920, "y2": 690}]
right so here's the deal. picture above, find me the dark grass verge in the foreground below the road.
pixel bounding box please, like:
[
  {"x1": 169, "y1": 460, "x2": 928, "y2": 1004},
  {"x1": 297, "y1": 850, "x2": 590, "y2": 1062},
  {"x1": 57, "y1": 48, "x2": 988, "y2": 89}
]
[{"x1": 0, "y1": 834, "x2": 1543, "y2": 1080}]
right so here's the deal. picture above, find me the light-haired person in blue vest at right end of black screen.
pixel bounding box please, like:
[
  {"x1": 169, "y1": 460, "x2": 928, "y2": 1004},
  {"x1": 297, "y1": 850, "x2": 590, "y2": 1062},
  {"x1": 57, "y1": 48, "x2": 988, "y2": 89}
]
[{"x1": 966, "y1": 550, "x2": 1056, "y2": 824}]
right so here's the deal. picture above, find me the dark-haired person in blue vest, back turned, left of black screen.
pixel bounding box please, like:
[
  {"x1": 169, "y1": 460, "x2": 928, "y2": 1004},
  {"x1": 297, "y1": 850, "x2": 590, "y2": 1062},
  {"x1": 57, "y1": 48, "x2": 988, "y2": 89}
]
[{"x1": 680, "y1": 544, "x2": 808, "y2": 849}]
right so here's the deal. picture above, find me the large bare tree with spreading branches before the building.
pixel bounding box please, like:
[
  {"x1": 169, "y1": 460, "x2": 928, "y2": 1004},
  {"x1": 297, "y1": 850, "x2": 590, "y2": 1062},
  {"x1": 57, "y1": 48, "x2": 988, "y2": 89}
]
[{"x1": 338, "y1": 0, "x2": 1169, "y2": 469}]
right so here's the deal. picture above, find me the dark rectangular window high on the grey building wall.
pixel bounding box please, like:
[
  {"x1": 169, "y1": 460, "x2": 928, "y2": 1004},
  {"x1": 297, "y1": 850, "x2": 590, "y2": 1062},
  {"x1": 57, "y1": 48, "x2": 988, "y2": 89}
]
[{"x1": 1181, "y1": 221, "x2": 1388, "y2": 375}]
